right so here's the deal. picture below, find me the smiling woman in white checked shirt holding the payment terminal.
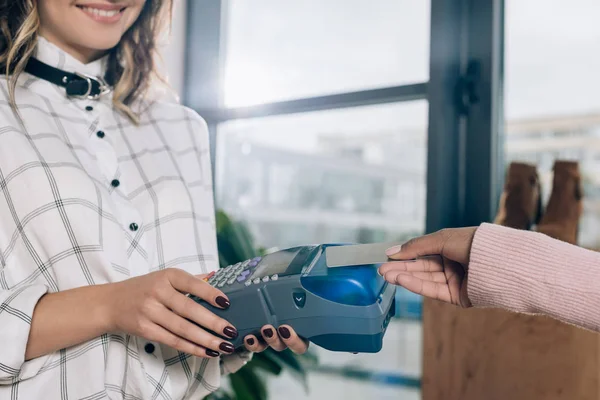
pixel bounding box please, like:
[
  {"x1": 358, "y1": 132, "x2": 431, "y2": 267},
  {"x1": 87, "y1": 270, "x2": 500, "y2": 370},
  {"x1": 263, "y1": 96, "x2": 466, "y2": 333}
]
[{"x1": 0, "y1": 0, "x2": 307, "y2": 400}]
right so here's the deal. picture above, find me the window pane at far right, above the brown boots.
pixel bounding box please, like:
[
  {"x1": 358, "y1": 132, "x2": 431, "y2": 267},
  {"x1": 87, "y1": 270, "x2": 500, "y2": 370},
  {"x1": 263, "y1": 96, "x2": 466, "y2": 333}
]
[{"x1": 505, "y1": 0, "x2": 600, "y2": 248}]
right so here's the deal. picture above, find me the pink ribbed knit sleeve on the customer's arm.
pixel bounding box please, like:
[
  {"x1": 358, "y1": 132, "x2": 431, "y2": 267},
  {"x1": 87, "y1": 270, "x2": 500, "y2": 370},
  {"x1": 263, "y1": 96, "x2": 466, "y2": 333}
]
[{"x1": 468, "y1": 224, "x2": 600, "y2": 331}]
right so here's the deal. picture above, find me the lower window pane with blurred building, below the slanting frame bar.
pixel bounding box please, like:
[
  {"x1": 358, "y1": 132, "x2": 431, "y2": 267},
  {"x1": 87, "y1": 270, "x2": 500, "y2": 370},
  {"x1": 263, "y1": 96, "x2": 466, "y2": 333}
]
[{"x1": 216, "y1": 100, "x2": 428, "y2": 400}]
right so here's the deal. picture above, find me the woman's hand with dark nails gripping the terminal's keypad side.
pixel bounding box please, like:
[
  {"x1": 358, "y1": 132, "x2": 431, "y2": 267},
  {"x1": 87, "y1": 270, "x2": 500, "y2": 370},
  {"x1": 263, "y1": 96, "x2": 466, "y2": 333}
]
[{"x1": 109, "y1": 268, "x2": 238, "y2": 358}]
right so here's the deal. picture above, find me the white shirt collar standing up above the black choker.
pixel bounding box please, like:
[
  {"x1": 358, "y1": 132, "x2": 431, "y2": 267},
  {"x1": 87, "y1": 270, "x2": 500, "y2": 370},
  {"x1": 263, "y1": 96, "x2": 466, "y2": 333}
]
[{"x1": 35, "y1": 36, "x2": 108, "y2": 76}]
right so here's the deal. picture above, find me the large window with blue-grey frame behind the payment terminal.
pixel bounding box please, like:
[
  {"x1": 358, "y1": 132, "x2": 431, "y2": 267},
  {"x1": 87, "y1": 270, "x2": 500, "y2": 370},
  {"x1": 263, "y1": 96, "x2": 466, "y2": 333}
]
[{"x1": 186, "y1": 0, "x2": 501, "y2": 400}]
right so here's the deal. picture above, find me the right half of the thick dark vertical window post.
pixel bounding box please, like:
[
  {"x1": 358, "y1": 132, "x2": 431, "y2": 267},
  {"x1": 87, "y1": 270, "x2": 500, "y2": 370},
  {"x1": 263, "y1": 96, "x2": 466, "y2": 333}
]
[{"x1": 463, "y1": 0, "x2": 504, "y2": 226}]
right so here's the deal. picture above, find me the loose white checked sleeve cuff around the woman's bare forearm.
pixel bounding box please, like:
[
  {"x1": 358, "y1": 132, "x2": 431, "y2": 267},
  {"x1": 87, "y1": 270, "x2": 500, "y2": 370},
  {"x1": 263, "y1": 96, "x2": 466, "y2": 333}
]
[{"x1": 0, "y1": 285, "x2": 50, "y2": 385}]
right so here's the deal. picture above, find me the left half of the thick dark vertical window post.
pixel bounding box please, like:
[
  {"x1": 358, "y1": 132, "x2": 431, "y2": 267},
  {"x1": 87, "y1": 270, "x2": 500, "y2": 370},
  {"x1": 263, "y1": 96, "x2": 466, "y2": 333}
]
[{"x1": 426, "y1": 0, "x2": 466, "y2": 232}]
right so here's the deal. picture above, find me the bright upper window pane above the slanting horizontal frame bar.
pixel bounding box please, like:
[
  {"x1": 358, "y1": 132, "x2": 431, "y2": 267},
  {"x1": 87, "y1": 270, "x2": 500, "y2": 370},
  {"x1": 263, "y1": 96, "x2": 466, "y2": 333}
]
[{"x1": 224, "y1": 0, "x2": 430, "y2": 107}]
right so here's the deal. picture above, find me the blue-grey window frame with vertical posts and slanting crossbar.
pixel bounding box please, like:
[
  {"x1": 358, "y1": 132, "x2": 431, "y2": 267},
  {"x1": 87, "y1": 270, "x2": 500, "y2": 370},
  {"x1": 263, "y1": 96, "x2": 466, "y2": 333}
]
[{"x1": 183, "y1": 0, "x2": 505, "y2": 390}]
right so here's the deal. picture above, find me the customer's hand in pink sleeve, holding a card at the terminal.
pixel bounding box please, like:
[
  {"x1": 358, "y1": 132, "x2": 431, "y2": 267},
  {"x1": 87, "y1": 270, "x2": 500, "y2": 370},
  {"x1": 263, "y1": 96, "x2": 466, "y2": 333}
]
[{"x1": 379, "y1": 228, "x2": 477, "y2": 307}]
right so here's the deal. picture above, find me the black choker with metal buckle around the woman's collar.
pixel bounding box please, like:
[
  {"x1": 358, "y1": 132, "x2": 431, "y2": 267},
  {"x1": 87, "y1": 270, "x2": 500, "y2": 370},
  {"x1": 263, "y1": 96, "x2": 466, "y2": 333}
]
[{"x1": 25, "y1": 57, "x2": 111, "y2": 100}]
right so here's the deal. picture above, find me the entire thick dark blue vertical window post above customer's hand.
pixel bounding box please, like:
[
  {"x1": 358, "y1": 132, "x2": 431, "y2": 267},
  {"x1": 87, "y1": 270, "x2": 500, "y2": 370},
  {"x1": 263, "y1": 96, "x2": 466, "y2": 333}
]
[{"x1": 427, "y1": 0, "x2": 504, "y2": 232}]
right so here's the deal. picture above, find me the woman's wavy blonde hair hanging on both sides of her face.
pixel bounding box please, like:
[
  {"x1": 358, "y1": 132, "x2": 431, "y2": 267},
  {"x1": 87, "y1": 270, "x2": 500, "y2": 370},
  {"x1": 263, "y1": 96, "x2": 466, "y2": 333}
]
[{"x1": 0, "y1": 0, "x2": 173, "y2": 122}]
